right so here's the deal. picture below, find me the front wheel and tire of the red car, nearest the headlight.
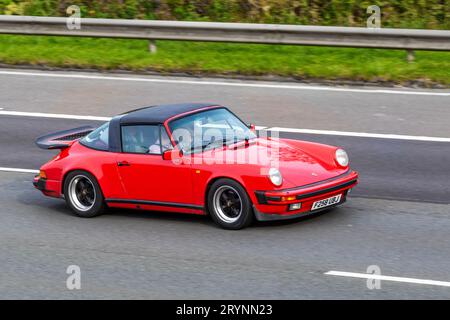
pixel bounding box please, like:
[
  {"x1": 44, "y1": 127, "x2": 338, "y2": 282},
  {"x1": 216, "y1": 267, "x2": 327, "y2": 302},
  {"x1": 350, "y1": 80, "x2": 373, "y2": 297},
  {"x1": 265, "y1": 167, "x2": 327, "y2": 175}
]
[{"x1": 207, "y1": 179, "x2": 253, "y2": 230}]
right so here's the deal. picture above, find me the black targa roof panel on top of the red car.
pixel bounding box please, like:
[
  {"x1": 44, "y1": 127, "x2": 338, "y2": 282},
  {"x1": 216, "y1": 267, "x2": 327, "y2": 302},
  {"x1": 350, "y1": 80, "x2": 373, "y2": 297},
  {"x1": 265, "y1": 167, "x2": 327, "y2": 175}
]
[{"x1": 120, "y1": 103, "x2": 216, "y2": 124}]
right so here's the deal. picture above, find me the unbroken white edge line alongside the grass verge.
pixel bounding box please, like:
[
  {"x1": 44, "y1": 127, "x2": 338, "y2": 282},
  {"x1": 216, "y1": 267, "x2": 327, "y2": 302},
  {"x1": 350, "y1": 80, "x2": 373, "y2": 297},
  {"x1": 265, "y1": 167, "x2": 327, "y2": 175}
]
[{"x1": 0, "y1": 71, "x2": 450, "y2": 97}]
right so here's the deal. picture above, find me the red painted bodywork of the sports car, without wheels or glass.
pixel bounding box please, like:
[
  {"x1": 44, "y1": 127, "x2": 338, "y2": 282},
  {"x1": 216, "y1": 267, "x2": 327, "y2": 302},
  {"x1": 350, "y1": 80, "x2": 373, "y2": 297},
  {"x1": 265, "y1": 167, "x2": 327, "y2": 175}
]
[{"x1": 34, "y1": 104, "x2": 358, "y2": 224}]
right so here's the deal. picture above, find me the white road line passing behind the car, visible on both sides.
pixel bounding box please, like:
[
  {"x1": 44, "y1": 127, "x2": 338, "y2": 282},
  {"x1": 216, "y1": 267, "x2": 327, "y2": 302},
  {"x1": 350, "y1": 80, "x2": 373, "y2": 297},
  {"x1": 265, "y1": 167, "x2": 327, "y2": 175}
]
[{"x1": 0, "y1": 110, "x2": 450, "y2": 142}]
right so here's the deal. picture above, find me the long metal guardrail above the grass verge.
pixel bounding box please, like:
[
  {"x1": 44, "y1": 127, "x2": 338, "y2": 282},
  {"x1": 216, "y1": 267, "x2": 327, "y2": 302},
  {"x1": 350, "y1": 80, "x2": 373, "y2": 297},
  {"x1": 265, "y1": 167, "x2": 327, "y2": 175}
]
[{"x1": 0, "y1": 15, "x2": 450, "y2": 58}]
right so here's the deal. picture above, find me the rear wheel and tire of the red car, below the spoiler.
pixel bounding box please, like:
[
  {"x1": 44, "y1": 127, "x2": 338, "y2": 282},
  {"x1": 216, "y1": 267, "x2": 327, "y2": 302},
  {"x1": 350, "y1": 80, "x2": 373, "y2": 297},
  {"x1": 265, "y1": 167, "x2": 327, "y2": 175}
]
[{"x1": 64, "y1": 170, "x2": 105, "y2": 218}]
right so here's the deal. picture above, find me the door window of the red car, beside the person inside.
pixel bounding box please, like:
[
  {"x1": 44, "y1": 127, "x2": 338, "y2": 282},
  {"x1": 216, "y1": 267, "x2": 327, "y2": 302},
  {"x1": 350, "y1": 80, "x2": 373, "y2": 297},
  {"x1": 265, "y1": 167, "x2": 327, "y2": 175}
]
[{"x1": 121, "y1": 125, "x2": 161, "y2": 154}]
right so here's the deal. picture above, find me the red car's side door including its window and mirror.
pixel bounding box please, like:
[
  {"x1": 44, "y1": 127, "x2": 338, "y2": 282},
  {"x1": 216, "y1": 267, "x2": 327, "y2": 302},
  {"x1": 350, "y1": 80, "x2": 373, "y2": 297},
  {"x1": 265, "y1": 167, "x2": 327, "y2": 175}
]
[{"x1": 117, "y1": 124, "x2": 192, "y2": 206}]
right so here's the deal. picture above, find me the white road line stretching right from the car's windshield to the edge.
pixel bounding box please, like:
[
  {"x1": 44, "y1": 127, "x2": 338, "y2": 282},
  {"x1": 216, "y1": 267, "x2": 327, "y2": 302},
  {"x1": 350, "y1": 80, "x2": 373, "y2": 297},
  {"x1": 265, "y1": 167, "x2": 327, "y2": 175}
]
[{"x1": 266, "y1": 127, "x2": 450, "y2": 142}]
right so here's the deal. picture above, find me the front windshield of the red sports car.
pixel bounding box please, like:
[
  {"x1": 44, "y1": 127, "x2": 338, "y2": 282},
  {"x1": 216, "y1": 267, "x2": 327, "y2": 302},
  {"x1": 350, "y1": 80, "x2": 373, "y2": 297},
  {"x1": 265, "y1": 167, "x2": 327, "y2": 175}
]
[{"x1": 169, "y1": 108, "x2": 256, "y2": 153}]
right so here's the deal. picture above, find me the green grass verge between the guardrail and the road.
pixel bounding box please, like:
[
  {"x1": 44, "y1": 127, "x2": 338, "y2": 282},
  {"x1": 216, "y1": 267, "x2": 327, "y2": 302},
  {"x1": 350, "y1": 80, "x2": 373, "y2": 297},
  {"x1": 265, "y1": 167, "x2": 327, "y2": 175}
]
[{"x1": 0, "y1": 35, "x2": 450, "y2": 86}]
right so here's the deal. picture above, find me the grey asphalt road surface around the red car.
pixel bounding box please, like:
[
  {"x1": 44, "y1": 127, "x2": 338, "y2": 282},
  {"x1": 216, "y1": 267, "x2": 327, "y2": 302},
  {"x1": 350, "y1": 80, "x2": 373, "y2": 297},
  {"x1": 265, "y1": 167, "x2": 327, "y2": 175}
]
[{"x1": 0, "y1": 69, "x2": 450, "y2": 299}]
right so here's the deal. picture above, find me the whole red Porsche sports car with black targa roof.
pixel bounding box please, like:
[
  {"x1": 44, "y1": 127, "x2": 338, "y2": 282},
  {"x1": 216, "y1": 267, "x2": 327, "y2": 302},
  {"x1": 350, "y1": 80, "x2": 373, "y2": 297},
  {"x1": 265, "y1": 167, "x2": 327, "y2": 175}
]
[{"x1": 34, "y1": 104, "x2": 358, "y2": 229}]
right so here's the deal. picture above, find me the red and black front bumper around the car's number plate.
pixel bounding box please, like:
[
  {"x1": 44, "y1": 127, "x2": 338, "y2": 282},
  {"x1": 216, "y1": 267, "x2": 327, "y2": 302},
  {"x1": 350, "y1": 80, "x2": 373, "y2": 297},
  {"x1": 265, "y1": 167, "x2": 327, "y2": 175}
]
[{"x1": 253, "y1": 170, "x2": 358, "y2": 221}]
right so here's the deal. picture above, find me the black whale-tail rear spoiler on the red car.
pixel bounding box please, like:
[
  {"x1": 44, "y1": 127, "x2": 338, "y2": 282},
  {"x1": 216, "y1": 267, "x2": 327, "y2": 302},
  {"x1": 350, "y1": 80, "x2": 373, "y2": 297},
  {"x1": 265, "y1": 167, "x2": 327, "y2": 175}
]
[{"x1": 34, "y1": 126, "x2": 95, "y2": 150}]
